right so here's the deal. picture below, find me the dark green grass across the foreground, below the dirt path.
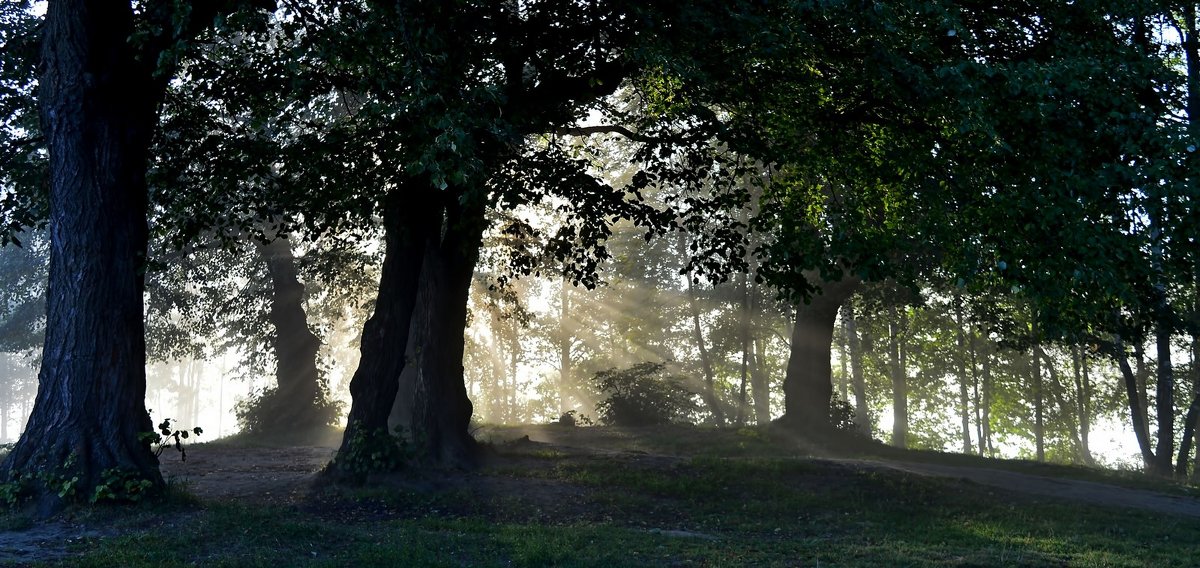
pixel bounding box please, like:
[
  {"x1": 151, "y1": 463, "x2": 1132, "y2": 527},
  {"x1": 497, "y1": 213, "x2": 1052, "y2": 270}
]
[{"x1": 7, "y1": 429, "x2": 1200, "y2": 567}]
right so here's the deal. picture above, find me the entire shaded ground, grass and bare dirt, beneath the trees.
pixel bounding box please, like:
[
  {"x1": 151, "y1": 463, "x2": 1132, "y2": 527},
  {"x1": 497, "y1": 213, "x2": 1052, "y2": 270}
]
[{"x1": 0, "y1": 426, "x2": 1200, "y2": 567}]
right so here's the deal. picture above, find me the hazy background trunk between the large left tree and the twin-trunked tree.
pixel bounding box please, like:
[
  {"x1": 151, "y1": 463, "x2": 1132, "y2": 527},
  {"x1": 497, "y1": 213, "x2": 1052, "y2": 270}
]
[{"x1": 258, "y1": 235, "x2": 330, "y2": 432}]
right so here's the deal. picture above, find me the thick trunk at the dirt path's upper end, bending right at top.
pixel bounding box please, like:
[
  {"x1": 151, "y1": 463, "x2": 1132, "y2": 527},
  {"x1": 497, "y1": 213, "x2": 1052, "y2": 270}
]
[{"x1": 780, "y1": 276, "x2": 862, "y2": 434}]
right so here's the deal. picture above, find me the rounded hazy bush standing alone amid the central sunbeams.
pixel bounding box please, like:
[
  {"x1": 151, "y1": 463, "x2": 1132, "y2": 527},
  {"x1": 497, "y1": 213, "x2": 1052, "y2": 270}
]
[{"x1": 592, "y1": 363, "x2": 698, "y2": 426}]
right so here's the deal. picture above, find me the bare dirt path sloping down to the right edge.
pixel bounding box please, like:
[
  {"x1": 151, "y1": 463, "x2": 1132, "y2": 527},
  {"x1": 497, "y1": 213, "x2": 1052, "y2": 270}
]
[{"x1": 828, "y1": 459, "x2": 1200, "y2": 516}]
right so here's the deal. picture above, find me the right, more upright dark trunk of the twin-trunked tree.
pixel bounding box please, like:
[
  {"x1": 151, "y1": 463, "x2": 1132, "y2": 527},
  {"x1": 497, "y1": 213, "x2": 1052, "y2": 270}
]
[{"x1": 412, "y1": 194, "x2": 486, "y2": 467}]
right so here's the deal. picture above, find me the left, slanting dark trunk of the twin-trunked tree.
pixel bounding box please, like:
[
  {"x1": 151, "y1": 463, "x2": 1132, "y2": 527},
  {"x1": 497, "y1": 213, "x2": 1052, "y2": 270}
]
[{"x1": 340, "y1": 183, "x2": 438, "y2": 465}]
